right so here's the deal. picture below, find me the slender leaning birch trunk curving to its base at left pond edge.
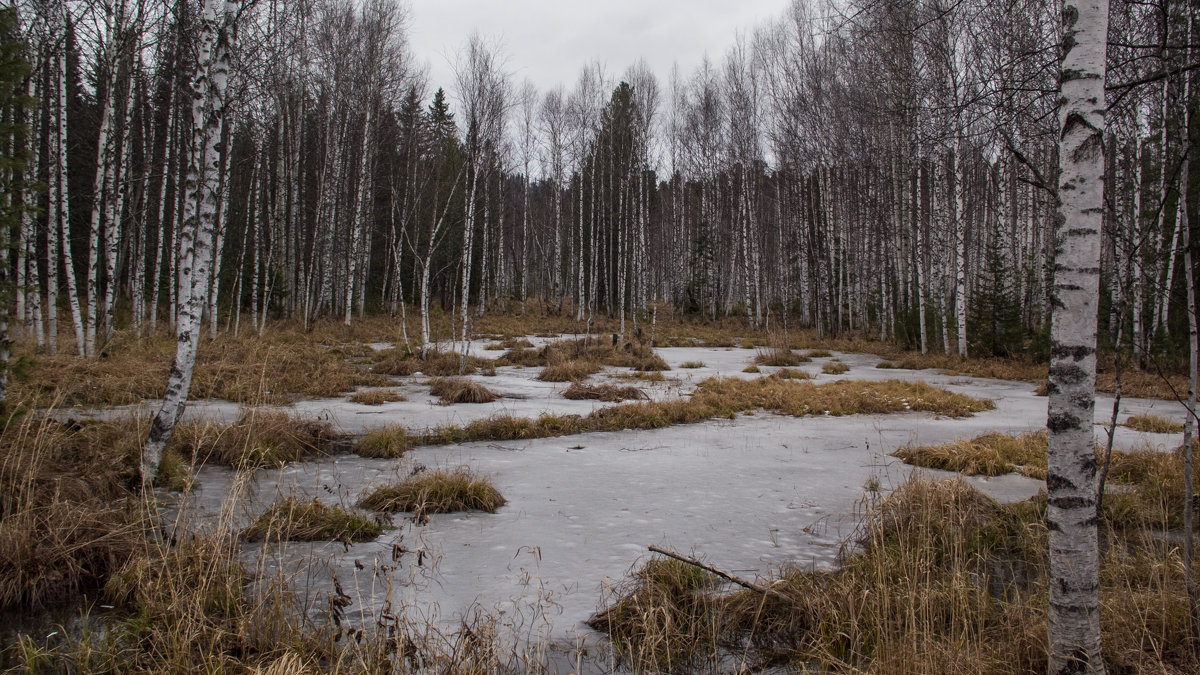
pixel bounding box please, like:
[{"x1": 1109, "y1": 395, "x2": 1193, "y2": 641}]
[{"x1": 142, "y1": 0, "x2": 236, "y2": 488}]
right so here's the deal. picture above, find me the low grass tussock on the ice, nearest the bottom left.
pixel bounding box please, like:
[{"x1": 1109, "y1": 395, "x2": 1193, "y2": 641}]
[{"x1": 241, "y1": 497, "x2": 385, "y2": 542}]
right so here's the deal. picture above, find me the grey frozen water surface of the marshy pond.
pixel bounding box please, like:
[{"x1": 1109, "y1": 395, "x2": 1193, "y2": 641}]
[{"x1": 110, "y1": 344, "x2": 1183, "y2": 658}]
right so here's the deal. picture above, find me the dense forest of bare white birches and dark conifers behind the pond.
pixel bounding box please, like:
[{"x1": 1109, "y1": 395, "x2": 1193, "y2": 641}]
[{"x1": 7, "y1": 0, "x2": 1194, "y2": 360}]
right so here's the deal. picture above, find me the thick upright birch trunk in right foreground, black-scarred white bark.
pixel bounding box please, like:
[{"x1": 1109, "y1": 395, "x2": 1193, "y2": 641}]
[{"x1": 1046, "y1": 0, "x2": 1108, "y2": 674}]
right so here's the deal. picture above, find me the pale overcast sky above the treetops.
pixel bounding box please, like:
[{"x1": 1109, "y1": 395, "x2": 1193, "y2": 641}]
[{"x1": 409, "y1": 0, "x2": 790, "y2": 97}]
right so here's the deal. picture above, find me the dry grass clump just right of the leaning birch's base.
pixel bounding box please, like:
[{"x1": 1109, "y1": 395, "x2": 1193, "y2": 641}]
[{"x1": 172, "y1": 408, "x2": 348, "y2": 468}]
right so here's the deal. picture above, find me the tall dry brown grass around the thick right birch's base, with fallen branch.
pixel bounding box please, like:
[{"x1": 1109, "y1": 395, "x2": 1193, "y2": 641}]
[{"x1": 590, "y1": 478, "x2": 1200, "y2": 673}]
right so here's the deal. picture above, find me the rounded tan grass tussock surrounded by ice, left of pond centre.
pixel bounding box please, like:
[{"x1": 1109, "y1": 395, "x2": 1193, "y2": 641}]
[{"x1": 359, "y1": 467, "x2": 506, "y2": 516}]
